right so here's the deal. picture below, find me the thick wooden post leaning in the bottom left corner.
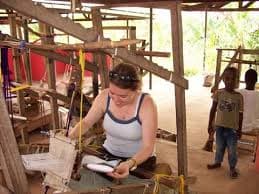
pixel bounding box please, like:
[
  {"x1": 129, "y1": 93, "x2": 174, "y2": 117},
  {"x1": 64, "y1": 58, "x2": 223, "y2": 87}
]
[{"x1": 0, "y1": 90, "x2": 29, "y2": 194}]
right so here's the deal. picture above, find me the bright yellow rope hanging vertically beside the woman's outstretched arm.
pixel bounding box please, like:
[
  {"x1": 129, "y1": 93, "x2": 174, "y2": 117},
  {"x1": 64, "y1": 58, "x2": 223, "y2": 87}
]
[{"x1": 78, "y1": 49, "x2": 85, "y2": 152}]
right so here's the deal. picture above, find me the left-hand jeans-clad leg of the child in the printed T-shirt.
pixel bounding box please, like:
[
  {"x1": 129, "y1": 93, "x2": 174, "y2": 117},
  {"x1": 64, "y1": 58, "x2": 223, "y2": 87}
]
[{"x1": 215, "y1": 127, "x2": 227, "y2": 164}]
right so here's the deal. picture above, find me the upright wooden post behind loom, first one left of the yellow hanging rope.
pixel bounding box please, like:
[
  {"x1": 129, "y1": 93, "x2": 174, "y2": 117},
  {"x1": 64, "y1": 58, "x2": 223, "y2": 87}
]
[{"x1": 39, "y1": 23, "x2": 59, "y2": 129}]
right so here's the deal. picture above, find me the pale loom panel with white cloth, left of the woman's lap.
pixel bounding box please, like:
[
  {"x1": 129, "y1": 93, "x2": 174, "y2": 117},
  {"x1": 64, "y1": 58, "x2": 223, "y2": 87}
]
[{"x1": 22, "y1": 132, "x2": 78, "y2": 192}]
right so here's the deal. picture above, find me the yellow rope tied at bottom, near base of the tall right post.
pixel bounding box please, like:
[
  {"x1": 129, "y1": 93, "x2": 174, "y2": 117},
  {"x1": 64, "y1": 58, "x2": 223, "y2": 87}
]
[{"x1": 153, "y1": 174, "x2": 185, "y2": 194}]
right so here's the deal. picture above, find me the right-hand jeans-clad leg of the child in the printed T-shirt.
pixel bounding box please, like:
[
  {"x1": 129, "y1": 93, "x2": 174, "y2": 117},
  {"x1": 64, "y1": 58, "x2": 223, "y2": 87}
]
[{"x1": 227, "y1": 129, "x2": 237, "y2": 169}]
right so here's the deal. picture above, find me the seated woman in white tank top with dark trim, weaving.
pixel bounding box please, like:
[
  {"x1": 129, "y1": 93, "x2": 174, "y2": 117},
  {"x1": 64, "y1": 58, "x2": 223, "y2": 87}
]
[{"x1": 69, "y1": 63, "x2": 157, "y2": 178}]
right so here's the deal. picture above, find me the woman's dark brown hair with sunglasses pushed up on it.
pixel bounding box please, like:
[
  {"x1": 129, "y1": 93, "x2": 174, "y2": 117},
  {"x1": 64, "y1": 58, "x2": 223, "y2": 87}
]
[{"x1": 109, "y1": 63, "x2": 141, "y2": 91}]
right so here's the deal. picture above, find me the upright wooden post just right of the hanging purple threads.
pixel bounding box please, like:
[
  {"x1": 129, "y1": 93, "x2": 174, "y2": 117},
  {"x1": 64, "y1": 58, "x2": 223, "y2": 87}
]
[{"x1": 8, "y1": 14, "x2": 25, "y2": 116}]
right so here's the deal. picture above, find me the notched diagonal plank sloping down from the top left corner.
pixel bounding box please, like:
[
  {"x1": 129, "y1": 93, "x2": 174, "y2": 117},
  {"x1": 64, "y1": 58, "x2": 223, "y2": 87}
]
[{"x1": 0, "y1": 0, "x2": 97, "y2": 42}]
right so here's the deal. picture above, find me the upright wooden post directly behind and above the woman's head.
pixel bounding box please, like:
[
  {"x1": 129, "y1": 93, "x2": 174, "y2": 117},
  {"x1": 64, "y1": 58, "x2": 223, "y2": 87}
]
[{"x1": 91, "y1": 8, "x2": 109, "y2": 89}]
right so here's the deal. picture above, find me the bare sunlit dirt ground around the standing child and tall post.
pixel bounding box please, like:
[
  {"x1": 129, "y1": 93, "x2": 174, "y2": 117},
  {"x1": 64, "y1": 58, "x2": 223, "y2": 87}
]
[{"x1": 22, "y1": 76, "x2": 259, "y2": 194}]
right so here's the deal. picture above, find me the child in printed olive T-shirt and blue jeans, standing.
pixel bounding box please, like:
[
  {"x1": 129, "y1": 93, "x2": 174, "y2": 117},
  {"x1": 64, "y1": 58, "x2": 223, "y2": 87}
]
[{"x1": 207, "y1": 67, "x2": 243, "y2": 178}]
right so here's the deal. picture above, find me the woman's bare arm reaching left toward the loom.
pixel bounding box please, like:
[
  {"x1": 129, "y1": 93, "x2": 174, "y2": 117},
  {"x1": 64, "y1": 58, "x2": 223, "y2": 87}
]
[{"x1": 69, "y1": 90, "x2": 108, "y2": 139}]
